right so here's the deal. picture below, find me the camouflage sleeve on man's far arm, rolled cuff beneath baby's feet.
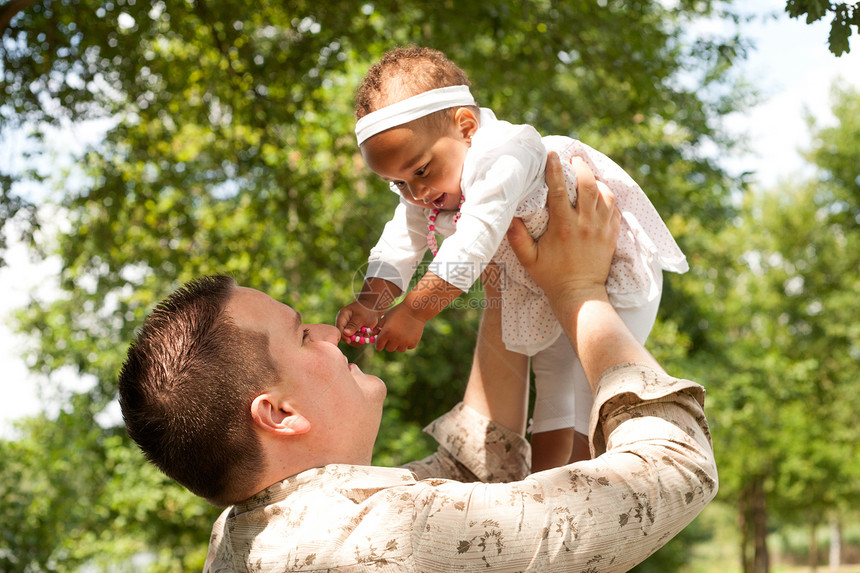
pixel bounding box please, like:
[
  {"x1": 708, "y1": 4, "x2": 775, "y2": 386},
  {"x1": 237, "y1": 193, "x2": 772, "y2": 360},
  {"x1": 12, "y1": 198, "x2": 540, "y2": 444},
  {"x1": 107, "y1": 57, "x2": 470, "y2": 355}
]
[{"x1": 403, "y1": 402, "x2": 531, "y2": 482}]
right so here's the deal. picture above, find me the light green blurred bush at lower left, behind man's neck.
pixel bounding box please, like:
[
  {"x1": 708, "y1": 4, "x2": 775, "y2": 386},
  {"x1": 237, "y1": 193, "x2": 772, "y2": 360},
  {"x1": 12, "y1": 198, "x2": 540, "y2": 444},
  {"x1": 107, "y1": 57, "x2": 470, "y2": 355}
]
[{"x1": 0, "y1": 396, "x2": 218, "y2": 572}]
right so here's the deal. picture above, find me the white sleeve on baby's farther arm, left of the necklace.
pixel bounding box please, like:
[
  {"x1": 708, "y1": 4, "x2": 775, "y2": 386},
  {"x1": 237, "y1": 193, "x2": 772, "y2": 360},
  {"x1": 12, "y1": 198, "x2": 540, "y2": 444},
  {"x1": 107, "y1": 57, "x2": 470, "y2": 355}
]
[{"x1": 365, "y1": 198, "x2": 427, "y2": 291}]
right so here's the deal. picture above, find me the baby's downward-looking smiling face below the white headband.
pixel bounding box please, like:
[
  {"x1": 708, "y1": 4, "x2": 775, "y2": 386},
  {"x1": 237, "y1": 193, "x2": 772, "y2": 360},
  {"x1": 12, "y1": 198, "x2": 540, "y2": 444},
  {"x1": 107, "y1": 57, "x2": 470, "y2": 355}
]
[{"x1": 361, "y1": 113, "x2": 469, "y2": 211}]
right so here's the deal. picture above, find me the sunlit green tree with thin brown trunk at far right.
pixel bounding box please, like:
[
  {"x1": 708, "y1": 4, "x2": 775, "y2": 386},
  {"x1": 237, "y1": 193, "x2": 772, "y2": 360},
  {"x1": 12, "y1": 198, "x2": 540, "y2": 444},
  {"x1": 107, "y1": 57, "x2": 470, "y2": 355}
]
[{"x1": 694, "y1": 82, "x2": 860, "y2": 572}]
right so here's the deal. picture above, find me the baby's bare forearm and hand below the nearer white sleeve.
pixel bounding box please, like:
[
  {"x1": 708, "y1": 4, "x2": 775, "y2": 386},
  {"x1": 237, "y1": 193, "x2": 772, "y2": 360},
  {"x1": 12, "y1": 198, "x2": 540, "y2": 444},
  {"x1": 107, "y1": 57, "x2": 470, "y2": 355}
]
[{"x1": 376, "y1": 271, "x2": 463, "y2": 352}]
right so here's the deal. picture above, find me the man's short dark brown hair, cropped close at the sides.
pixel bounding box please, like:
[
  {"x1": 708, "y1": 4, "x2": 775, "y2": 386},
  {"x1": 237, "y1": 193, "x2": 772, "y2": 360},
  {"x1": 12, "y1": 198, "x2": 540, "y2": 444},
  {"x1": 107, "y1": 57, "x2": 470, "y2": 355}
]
[{"x1": 118, "y1": 276, "x2": 277, "y2": 505}]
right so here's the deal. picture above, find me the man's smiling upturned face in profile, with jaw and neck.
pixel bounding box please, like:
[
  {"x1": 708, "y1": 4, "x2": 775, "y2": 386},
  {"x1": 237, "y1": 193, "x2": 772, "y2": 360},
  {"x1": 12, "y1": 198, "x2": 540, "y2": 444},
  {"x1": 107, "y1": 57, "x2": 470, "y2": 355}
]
[{"x1": 227, "y1": 287, "x2": 386, "y2": 464}]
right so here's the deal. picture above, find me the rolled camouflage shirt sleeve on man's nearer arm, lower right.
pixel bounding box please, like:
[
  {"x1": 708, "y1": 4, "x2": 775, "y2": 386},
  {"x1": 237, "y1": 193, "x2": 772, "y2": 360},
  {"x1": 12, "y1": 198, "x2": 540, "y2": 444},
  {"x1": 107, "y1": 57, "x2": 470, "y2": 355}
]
[{"x1": 406, "y1": 365, "x2": 717, "y2": 573}]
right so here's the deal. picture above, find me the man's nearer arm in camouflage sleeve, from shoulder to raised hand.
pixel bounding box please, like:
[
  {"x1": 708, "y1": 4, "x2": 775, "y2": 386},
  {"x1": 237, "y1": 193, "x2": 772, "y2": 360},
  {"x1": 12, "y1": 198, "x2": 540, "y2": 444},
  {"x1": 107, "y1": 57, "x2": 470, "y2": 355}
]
[{"x1": 406, "y1": 154, "x2": 717, "y2": 573}]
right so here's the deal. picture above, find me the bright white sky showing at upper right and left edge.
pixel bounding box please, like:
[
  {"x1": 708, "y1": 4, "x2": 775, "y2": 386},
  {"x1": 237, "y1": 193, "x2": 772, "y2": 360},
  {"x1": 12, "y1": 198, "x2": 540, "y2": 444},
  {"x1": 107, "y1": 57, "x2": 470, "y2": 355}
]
[{"x1": 0, "y1": 0, "x2": 860, "y2": 438}]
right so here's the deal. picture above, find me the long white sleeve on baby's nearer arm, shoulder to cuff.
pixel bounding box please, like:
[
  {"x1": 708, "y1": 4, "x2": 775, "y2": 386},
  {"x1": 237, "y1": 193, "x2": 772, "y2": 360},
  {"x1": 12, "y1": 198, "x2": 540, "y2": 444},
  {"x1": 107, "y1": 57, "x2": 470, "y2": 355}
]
[{"x1": 429, "y1": 121, "x2": 546, "y2": 292}]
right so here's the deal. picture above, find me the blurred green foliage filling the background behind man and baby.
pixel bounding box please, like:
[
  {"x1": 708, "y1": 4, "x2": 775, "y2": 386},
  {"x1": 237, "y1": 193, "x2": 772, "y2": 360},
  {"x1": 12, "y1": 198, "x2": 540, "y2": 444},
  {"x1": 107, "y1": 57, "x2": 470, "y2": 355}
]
[{"x1": 0, "y1": 0, "x2": 860, "y2": 571}]
